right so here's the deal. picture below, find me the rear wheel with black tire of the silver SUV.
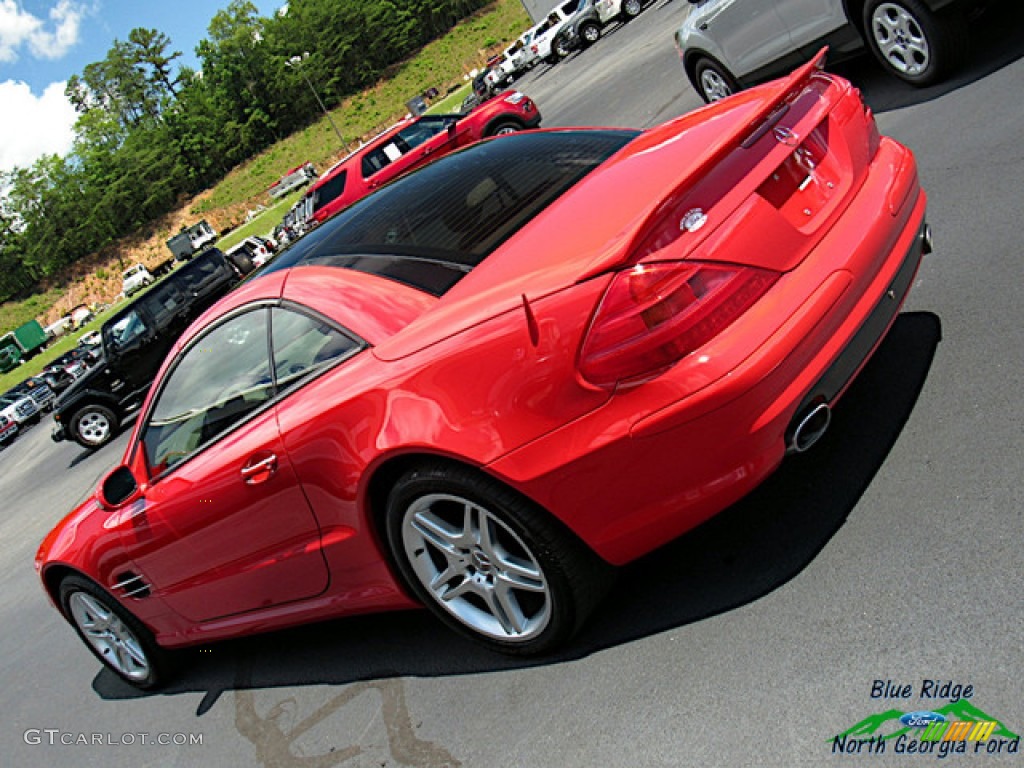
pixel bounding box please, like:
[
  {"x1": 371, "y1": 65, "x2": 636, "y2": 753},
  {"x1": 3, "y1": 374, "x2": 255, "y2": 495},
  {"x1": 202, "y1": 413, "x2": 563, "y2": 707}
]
[{"x1": 863, "y1": 0, "x2": 970, "y2": 87}]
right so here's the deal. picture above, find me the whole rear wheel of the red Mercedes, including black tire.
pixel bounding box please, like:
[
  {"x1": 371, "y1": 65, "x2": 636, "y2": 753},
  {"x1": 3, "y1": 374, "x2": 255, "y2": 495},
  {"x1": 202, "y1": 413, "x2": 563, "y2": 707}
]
[{"x1": 386, "y1": 463, "x2": 612, "y2": 656}]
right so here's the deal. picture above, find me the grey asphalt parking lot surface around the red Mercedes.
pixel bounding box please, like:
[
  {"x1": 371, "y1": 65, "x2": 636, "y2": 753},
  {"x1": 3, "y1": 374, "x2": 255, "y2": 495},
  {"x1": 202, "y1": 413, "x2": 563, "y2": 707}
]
[{"x1": 0, "y1": 0, "x2": 1024, "y2": 768}]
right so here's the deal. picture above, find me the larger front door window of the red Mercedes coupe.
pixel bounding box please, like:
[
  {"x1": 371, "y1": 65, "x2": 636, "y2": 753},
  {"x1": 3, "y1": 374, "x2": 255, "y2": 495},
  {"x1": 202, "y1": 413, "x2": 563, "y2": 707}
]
[{"x1": 142, "y1": 308, "x2": 273, "y2": 472}]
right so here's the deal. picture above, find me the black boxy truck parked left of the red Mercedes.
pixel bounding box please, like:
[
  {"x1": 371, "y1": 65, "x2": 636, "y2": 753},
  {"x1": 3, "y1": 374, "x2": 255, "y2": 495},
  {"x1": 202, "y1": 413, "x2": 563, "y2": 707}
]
[{"x1": 51, "y1": 248, "x2": 243, "y2": 449}]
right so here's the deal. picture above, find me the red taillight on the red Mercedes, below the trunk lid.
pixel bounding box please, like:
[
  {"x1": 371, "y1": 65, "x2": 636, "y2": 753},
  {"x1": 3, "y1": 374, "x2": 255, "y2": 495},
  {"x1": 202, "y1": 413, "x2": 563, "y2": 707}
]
[{"x1": 580, "y1": 261, "x2": 779, "y2": 387}]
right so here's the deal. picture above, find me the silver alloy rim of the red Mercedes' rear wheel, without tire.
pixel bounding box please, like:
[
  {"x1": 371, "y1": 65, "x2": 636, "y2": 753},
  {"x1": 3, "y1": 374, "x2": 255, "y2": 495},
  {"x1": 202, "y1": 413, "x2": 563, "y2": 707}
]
[{"x1": 401, "y1": 494, "x2": 551, "y2": 643}]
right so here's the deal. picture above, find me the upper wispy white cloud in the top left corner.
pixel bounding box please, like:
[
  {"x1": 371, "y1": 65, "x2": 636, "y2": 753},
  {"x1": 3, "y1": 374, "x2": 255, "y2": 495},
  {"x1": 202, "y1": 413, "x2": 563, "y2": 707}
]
[{"x1": 0, "y1": 0, "x2": 85, "y2": 61}]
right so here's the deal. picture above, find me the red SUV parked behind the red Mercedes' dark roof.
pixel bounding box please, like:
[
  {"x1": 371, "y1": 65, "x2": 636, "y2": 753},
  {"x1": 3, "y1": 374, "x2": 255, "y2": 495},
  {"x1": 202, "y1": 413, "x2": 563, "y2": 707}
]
[{"x1": 306, "y1": 91, "x2": 541, "y2": 223}]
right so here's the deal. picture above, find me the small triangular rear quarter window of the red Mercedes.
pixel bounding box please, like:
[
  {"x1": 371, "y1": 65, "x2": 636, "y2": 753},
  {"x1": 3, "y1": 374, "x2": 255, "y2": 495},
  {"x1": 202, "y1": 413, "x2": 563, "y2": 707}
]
[{"x1": 270, "y1": 307, "x2": 359, "y2": 389}]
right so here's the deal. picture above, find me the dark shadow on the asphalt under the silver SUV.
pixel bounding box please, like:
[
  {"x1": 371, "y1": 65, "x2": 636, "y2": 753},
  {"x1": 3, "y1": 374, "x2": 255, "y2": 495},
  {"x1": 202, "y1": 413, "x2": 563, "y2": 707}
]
[{"x1": 828, "y1": 0, "x2": 1024, "y2": 114}]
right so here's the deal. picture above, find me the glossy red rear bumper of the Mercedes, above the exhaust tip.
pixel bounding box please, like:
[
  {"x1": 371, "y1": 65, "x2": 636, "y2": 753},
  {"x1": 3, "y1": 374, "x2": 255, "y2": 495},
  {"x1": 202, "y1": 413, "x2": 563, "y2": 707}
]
[{"x1": 487, "y1": 140, "x2": 926, "y2": 564}]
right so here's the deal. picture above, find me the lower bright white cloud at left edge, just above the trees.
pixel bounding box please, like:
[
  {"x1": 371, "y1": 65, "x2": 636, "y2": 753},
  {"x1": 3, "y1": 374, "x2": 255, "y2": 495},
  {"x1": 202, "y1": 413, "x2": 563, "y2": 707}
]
[{"x1": 0, "y1": 80, "x2": 78, "y2": 171}]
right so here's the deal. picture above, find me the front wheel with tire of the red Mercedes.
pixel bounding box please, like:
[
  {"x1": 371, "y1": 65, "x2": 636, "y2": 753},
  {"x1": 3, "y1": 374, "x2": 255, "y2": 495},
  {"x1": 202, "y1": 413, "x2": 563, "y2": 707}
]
[{"x1": 59, "y1": 574, "x2": 170, "y2": 690}]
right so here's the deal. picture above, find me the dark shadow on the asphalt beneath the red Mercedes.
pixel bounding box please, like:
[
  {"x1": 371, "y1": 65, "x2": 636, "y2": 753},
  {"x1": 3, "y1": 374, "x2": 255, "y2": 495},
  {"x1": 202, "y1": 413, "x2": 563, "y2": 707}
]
[{"x1": 93, "y1": 312, "x2": 941, "y2": 715}]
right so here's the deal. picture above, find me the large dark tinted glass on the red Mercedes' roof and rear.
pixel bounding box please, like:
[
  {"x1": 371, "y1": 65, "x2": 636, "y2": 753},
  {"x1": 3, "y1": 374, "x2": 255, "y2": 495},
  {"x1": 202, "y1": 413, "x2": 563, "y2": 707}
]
[{"x1": 267, "y1": 130, "x2": 637, "y2": 295}]
